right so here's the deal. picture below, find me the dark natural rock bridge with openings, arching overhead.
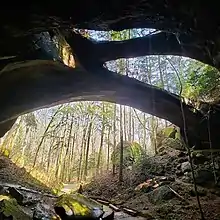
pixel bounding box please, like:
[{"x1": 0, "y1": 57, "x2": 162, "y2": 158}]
[{"x1": 0, "y1": 0, "x2": 220, "y2": 147}]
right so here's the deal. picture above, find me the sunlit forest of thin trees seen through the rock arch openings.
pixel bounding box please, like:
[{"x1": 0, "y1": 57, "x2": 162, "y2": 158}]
[{"x1": 0, "y1": 28, "x2": 220, "y2": 219}]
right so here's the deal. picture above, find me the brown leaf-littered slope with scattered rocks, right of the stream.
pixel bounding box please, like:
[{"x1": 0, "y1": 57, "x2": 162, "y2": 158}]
[{"x1": 84, "y1": 145, "x2": 220, "y2": 220}]
